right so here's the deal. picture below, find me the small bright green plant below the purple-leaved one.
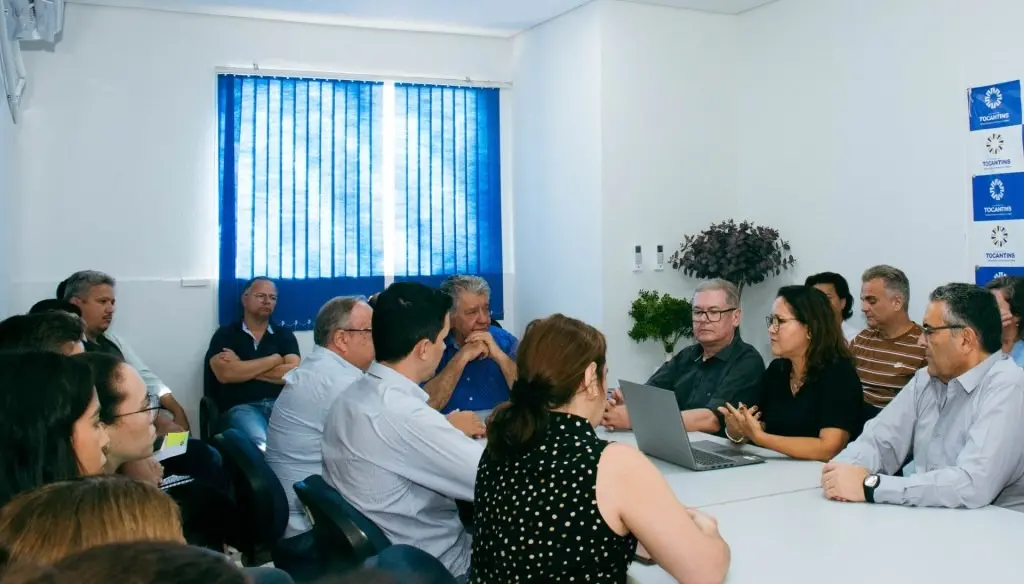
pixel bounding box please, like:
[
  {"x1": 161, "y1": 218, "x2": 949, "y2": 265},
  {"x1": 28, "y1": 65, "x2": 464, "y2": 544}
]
[{"x1": 629, "y1": 290, "x2": 693, "y2": 361}]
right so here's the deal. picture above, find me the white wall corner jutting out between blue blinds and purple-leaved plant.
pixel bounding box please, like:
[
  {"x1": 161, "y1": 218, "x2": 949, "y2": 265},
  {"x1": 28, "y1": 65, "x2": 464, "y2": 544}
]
[{"x1": 513, "y1": 1, "x2": 736, "y2": 383}]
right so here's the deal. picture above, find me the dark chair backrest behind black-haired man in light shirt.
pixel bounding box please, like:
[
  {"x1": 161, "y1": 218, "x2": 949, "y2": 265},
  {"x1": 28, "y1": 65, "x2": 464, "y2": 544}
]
[{"x1": 295, "y1": 474, "x2": 391, "y2": 562}]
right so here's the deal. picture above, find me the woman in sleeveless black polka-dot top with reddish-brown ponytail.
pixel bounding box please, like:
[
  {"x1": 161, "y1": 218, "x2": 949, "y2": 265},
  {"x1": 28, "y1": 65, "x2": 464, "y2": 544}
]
[{"x1": 470, "y1": 315, "x2": 729, "y2": 584}]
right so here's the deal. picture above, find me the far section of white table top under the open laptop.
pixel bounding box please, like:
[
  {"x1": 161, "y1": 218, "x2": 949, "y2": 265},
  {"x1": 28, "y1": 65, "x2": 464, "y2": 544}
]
[{"x1": 597, "y1": 429, "x2": 822, "y2": 507}]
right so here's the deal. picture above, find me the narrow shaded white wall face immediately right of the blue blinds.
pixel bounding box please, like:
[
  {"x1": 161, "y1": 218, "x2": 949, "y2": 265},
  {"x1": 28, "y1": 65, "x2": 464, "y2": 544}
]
[{"x1": 512, "y1": 4, "x2": 604, "y2": 327}]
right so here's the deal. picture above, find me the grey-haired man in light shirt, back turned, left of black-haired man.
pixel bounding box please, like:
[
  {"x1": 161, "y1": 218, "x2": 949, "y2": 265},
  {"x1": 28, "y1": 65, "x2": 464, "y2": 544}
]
[{"x1": 265, "y1": 296, "x2": 374, "y2": 537}]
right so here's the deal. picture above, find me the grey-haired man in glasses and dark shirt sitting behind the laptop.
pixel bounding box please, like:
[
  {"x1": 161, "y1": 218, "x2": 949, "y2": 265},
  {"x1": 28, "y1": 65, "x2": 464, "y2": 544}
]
[{"x1": 601, "y1": 280, "x2": 765, "y2": 433}]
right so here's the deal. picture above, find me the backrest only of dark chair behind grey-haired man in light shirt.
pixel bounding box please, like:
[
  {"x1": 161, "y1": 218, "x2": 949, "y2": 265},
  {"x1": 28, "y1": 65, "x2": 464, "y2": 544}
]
[{"x1": 213, "y1": 428, "x2": 288, "y2": 544}]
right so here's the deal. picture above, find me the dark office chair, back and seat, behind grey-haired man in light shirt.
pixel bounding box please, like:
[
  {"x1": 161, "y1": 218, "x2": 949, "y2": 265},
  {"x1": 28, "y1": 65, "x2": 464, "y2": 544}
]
[{"x1": 213, "y1": 428, "x2": 326, "y2": 580}]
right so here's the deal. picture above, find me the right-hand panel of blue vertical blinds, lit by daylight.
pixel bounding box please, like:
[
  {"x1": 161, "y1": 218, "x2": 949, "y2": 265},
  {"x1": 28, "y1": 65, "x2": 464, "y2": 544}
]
[{"x1": 394, "y1": 83, "x2": 504, "y2": 319}]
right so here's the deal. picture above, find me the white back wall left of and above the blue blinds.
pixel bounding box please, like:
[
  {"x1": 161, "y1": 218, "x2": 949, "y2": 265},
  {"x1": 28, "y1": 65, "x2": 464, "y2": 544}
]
[{"x1": 10, "y1": 4, "x2": 512, "y2": 416}]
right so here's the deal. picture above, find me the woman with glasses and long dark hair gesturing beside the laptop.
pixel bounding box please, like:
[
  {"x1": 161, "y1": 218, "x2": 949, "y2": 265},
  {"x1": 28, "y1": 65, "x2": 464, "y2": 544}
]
[{"x1": 719, "y1": 286, "x2": 863, "y2": 462}]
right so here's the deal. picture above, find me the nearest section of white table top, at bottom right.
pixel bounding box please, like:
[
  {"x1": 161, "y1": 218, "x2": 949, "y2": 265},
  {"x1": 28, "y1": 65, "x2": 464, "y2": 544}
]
[{"x1": 630, "y1": 485, "x2": 1024, "y2": 584}]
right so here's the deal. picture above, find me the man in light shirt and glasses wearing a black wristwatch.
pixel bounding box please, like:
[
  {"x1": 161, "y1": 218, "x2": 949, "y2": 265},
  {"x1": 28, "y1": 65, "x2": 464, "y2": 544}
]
[{"x1": 821, "y1": 284, "x2": 1024, "y2": 511}]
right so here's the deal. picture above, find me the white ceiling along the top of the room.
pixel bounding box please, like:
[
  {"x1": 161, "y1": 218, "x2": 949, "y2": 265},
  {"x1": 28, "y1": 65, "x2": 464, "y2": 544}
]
[{"x1": 68, "y1": 0, "x2": 775, "y2": 35}]
